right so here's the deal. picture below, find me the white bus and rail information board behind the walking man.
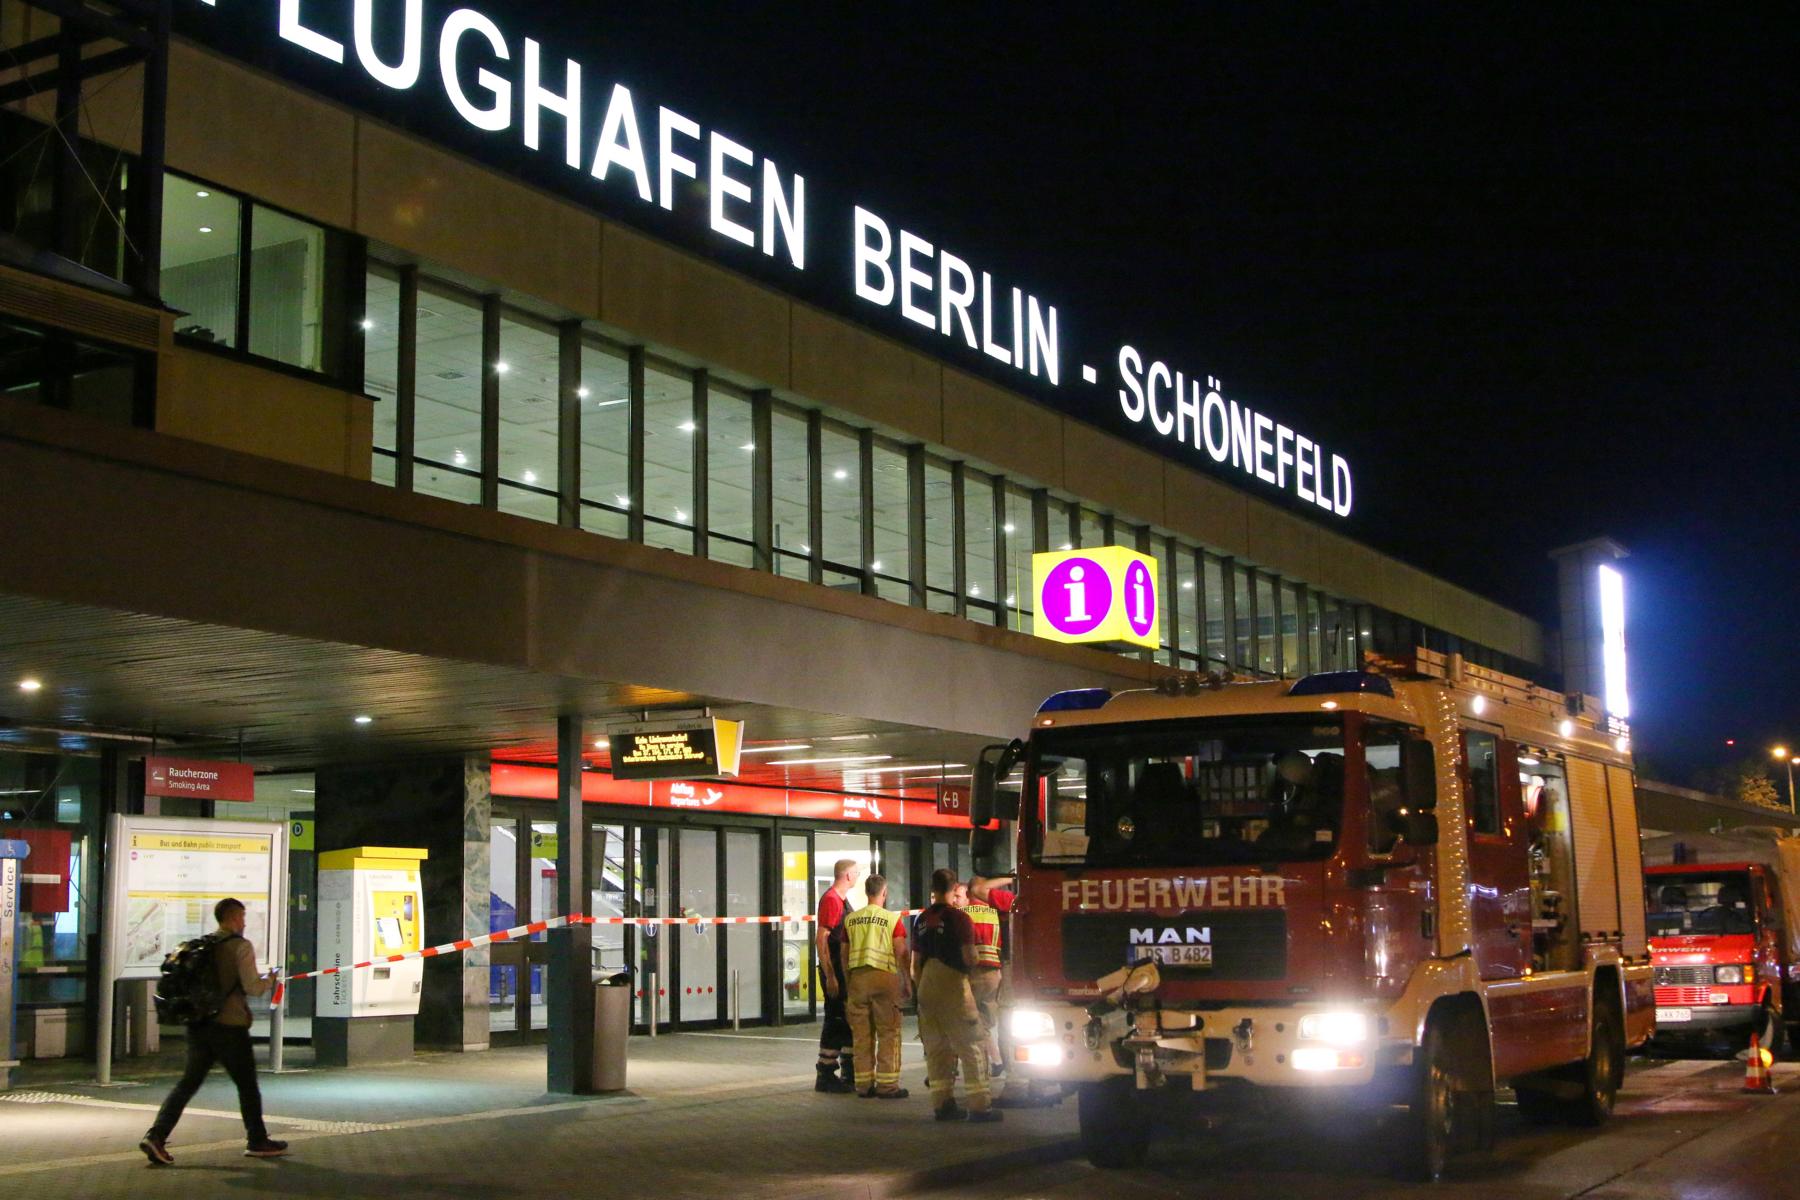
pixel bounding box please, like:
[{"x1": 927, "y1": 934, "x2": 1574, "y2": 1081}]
[{"x1": 108, "y1": 815, "x2": 288, "y2": 979}]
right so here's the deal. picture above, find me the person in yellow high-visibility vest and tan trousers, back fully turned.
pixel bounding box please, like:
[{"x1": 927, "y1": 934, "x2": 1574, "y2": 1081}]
[{"x1": 844, "y1": 874, "x2": 911, "y2": 1099}]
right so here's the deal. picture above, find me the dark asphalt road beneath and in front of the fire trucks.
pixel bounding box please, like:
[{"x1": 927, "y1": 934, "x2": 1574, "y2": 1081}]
[{"x1": 925, "y1": 1060, "x2": 1800, "y2": 1200}]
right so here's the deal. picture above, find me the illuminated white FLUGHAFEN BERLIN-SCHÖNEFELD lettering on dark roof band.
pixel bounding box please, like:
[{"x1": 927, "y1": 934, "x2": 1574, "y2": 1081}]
[{"x1": 178, "y1": 0, "x2": 1354, "y2": 516}]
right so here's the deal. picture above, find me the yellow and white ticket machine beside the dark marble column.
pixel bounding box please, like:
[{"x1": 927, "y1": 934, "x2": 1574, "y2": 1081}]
[{"x1": 313, "y1": 846, "x2": 427, "y2": 1067}]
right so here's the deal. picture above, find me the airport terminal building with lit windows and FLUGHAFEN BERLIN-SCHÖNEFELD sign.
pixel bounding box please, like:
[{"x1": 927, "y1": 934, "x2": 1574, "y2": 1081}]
[{"x1": 0, "y1": 0, "x2": 1611, "y2": 1056}]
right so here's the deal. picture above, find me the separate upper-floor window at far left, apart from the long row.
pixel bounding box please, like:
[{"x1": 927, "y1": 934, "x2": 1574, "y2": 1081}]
[{"x1": 162, "y1": 173, "x2": 351, "y2": 376}]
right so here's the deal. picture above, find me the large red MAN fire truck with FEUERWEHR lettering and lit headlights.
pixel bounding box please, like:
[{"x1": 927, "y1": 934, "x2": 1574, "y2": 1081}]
[{"x1": 972, "y1": 649, "x2": 1654, "y2": 1178}]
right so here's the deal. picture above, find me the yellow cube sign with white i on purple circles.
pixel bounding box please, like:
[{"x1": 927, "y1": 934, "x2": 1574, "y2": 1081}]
[{"x1": 1031, "y1": 545, "x2": 1163, "y2": 649}]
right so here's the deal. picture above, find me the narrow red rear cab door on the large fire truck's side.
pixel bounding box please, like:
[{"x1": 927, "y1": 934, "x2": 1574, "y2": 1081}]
[{"x1": 1462, "y1": 729, "x2": 1532, "y2": 979}]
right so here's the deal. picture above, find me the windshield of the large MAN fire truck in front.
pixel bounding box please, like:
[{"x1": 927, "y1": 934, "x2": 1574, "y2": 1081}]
[{"x1": 1026, "y1": 716, "x2": 1345, "y2": 867}]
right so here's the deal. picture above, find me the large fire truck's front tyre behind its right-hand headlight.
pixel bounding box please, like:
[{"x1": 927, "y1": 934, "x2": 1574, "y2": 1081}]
[{"x1": 1395, "y1": 1011, "x2": 1494, "y2": 1184}]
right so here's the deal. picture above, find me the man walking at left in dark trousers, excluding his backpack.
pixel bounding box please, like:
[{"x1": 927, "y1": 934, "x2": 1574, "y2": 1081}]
[{"x1": 137, "y1": 900, "x2": 288, "y2": 1166}]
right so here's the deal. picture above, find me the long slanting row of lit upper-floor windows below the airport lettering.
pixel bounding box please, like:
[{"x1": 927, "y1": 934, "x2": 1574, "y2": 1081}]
[{"x1": 361, "y1": 255, "x2": 1525, "y2": 676}]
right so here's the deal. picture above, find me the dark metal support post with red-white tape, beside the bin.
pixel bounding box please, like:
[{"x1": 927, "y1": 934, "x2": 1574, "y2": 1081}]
[{"x1": 544, "y1": 712, "x2": 594, "y2": 1096}]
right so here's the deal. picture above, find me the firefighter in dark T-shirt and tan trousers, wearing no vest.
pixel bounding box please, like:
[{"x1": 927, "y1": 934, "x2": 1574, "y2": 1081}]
[{"x1": 913, "y1": 869, "x2": 1001, "y2": 1121}]
